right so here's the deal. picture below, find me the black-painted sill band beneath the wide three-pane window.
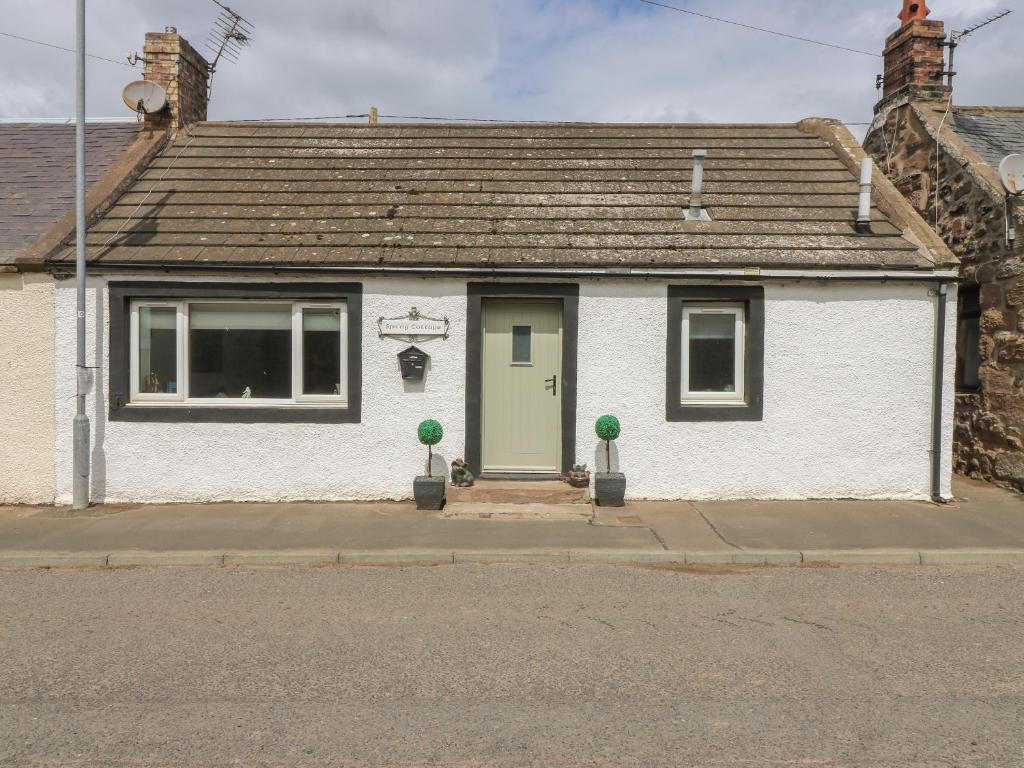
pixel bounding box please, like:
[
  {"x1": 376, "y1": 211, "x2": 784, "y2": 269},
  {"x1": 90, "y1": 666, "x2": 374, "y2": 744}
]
[{"x1": 110, "y1": 402, "x2": 359, "y2": 424}]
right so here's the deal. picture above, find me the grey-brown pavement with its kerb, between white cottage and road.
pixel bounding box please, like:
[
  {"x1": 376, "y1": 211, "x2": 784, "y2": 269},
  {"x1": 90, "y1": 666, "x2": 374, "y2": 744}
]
[{"x1": 0, "y1": 479, "x2": 1024, "y2": 567}]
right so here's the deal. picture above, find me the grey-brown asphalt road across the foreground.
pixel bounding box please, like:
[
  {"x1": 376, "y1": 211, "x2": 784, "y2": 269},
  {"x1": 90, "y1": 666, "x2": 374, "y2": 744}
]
[{"x1": 0, "y1": 565, "x2": 1024, "y2": 768}]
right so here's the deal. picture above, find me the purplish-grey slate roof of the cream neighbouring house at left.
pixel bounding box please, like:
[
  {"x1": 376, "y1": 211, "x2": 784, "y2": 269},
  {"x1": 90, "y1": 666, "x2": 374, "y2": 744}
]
[{"x1": 0, "y1": 122, "x2": 140, "y2": 264}]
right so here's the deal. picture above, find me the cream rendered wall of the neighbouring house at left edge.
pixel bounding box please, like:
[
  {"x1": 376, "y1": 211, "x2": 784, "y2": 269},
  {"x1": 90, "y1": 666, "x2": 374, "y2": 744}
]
[{"x1": 0, "y1": 274, "x2": 56, "y2": 504}]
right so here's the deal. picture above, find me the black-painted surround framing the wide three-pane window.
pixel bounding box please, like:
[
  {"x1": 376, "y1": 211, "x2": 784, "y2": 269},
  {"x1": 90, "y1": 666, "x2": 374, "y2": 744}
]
[{"x1": 108, "y1": 282, "x2": 362, "y2": 424}]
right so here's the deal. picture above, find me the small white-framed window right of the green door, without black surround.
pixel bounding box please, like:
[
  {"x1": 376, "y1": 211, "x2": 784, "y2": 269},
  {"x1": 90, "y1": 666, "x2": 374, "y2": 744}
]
[{"x1": 681, "y1": 304, "x2": 745, "y2": 402}]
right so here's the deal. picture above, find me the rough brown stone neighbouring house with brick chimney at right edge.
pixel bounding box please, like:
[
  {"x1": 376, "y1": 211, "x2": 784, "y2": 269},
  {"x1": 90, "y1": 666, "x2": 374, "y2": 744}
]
[{"x1": 864, "y1": 1, "x2": 1024, "y2": 489}]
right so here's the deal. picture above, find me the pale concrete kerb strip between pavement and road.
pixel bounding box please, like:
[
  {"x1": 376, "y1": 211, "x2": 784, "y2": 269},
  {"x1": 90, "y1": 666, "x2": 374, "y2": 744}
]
[{"x1": 0, "y1": 549, "x2": 1024, "y2": 568}]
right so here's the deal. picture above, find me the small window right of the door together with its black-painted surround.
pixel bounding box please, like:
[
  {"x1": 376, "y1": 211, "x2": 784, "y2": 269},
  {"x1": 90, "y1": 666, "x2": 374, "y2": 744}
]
[{"x1": 666, "y1": 286, "x2": 764, "y2": 421}]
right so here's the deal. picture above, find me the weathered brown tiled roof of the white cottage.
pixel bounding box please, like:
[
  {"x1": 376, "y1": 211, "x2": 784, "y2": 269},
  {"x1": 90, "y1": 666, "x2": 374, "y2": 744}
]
[{"x1": 51, "y1": 122, "x2": 950, "y2": 269}]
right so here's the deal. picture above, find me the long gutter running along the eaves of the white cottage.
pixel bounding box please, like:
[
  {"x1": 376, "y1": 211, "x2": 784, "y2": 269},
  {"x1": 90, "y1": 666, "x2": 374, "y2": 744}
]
[{"x1": 50, "y1": 260, "x2": 959, "y2": 284}]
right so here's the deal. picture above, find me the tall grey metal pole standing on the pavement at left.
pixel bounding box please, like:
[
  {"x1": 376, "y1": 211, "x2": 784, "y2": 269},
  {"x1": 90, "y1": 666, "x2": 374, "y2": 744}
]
[{"x1": 72, "y1": 0, "x2": 89, "y2": 510}]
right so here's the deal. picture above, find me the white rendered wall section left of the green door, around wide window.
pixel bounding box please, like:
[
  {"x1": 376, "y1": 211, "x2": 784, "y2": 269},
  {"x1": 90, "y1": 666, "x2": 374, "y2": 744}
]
[{"x1": 56, "y1": 278, "x2": 466, "y2": 502}]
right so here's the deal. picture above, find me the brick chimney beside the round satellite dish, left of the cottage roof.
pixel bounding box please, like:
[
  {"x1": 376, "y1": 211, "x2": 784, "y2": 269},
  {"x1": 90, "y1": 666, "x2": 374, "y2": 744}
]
[{"x1": 142, "y1": 27, "x2": 210, "y2": 134}]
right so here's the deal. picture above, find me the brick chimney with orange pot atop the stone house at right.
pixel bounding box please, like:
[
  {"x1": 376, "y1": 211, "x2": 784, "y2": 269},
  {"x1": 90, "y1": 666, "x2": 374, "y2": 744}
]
[{"x1": 874, "y1": 0, "x2": 950, "y2": 113}]
